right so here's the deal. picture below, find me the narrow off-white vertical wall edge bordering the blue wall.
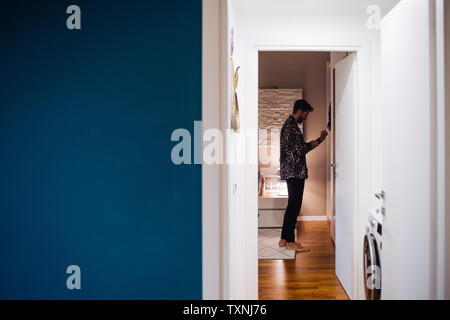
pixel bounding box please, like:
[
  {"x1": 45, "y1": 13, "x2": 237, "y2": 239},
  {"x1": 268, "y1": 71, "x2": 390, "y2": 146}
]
[{"x1": 202, "y1": 0, "x2": 222, "y2": 299}]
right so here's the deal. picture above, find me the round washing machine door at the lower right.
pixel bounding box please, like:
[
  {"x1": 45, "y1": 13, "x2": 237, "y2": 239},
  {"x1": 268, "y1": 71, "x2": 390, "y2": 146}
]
[{"x1": 364, "y1": 233, "x2": 381, "y2": 300}]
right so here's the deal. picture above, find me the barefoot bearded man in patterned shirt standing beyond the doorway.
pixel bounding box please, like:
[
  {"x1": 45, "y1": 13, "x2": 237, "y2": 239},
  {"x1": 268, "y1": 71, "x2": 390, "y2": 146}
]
[{"x1": 279, "y1": 100, "x2": 328, "y2": 252}]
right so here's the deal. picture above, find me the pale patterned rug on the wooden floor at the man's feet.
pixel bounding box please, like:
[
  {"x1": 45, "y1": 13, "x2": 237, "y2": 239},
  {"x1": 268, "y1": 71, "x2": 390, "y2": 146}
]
[{"x1": 258, "y1": 229, "x2": 295, "y2": 260}]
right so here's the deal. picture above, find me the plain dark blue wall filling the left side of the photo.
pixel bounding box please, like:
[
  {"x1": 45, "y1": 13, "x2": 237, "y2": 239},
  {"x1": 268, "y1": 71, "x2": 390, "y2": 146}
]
[{"x1": 0, "y1": 0, "x2": 202, "y2": 299}]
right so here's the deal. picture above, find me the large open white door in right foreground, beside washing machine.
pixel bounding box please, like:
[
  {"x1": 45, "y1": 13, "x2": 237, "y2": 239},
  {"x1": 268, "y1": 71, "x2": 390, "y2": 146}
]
[{"x1": 381, "y1": 0, "x2": 434, "y2": 299}]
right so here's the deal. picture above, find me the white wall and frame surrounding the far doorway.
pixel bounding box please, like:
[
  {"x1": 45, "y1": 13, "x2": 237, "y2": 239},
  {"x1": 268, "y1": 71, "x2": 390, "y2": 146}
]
[{"x1": 230, "y1": 5, "x2": 379, "y2": 299}]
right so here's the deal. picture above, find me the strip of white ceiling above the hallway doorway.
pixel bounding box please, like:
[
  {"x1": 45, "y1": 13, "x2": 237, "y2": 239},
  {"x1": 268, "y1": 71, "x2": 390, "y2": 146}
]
[{"x1": 234, "y1": 0, "x2": 400, "y2": 15}]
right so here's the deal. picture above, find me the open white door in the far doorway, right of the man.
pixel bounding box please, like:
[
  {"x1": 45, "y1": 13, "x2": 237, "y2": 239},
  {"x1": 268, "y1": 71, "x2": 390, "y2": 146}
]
[{"x1": 335, "y1": 54, "x2": 356, "y2": 299}]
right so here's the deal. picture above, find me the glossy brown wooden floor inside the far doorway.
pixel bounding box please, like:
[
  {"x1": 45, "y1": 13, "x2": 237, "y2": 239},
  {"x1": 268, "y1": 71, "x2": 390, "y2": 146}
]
[{"x1": 258, "y1": 221, "x2": 348, "y2": 300}]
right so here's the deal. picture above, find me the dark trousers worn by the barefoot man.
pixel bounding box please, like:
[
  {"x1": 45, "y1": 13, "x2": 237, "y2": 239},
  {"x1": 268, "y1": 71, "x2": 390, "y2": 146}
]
[{"x1": 281, "y1": 178, "x2": 305, "y2": 242}]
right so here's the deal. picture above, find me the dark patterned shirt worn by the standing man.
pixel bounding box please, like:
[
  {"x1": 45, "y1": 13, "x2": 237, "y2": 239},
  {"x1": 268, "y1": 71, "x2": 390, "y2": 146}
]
[{"x1": 280, "y1": 115, "x2": 312, "y2": 180}]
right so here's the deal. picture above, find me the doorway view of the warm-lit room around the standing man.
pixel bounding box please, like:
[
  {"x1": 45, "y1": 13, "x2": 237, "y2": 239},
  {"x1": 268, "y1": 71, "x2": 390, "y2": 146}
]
[{"x1": 258, "y1": 51, "x2": 356, "y2": 299}]
